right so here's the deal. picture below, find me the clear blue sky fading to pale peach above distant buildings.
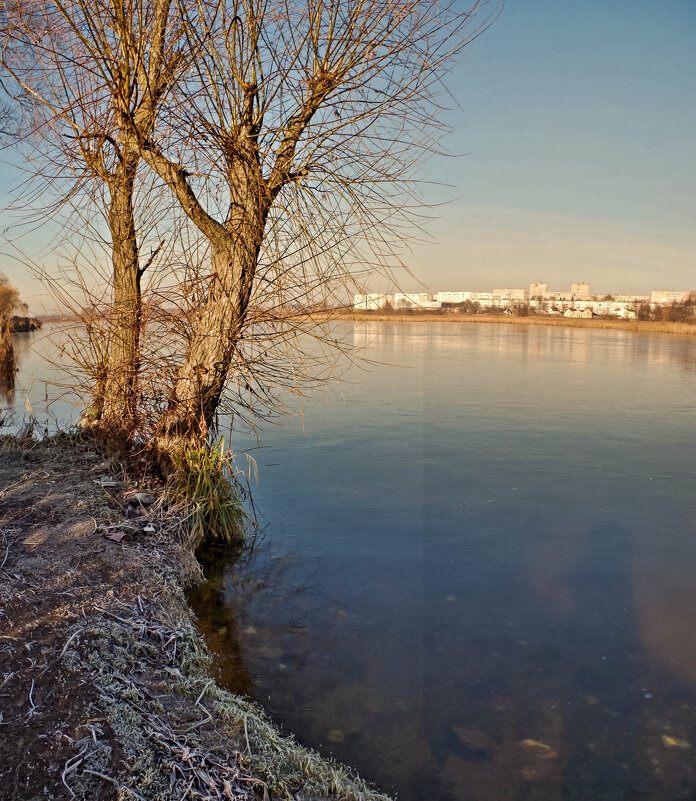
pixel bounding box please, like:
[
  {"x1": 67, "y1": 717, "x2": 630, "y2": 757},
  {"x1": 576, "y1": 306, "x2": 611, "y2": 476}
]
[{"x1": 0, "y1": 0, "x2": 696, "y2": 305}]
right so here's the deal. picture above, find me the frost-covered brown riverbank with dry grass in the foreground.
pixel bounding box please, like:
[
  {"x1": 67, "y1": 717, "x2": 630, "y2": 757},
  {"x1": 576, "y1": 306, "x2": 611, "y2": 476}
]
[{"x1": 0, "y1": 436, "x2": 387, "y2": 801}]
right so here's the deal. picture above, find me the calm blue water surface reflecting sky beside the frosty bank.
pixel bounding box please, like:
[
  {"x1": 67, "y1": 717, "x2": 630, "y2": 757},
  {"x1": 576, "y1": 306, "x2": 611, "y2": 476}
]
[{"x1": 8, "y1": 324, "x2": 696, "y2": 801}]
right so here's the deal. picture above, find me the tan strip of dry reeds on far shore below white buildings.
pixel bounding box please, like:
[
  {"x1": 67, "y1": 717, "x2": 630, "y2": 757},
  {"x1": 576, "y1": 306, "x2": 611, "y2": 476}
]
[{"x1": 334, "y1": 311, "x2": 696, "y2": 337}]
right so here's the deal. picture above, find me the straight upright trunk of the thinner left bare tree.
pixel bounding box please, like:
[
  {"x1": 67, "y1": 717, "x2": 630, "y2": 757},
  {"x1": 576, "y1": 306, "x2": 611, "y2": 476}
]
[{"x1": 98, "y1": 154, "x2": 142, "y2": 435}]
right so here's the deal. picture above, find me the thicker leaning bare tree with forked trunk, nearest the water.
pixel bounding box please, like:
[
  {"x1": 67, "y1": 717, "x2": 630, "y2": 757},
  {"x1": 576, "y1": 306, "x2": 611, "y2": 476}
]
[{"x1": 122, "y1": 0, "x2": 491, "y2": 452}]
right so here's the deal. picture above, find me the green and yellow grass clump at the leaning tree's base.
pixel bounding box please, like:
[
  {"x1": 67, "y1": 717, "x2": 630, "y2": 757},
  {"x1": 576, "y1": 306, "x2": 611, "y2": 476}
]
[{"x1": 167, "y1": 437, "x2": 248, "y2": 550}]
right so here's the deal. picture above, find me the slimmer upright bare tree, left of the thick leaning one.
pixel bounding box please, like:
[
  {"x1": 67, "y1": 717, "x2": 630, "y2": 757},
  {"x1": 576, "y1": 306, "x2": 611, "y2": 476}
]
[{"x1": 0, "y1": 0, "x2": 185, "y2": 434}]
